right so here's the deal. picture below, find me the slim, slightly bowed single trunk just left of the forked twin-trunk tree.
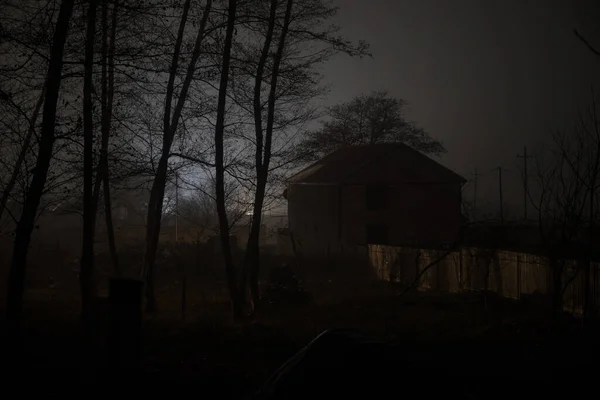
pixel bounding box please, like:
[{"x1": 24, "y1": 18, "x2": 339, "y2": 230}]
[{"x1": 215, "y1": 0, "x2": 243, "y2": 319}]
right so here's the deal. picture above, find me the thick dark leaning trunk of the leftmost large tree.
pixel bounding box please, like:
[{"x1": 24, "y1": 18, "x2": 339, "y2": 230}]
[{"x1": 6, "y1": 0, "x2": 74, "y2": 339}]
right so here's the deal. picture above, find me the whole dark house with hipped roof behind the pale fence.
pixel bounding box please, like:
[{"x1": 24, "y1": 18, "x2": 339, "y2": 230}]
[{"x1": 285, "y1": 144, "x2": 466, "y2": 254}]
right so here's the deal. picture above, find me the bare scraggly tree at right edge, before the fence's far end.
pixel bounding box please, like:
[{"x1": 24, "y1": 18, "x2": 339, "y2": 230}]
[{"x1": 529, "y1": 91, "x2": 600, "y2": 316}]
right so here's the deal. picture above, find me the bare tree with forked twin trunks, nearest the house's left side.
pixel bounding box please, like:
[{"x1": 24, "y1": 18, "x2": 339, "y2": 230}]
[{"x1": 242, "y1": 0, "x2": 368, "y2": 307}]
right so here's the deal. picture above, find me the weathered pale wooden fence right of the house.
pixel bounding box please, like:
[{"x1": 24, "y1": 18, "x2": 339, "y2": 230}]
[{"x1": 368, "y1": 245, "x2": 600, "y2": 314}]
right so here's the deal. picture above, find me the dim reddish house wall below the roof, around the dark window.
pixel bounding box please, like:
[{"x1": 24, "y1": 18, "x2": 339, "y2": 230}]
[{"x1": 288, "y1": 184, "x2": 461, "y2": 254}]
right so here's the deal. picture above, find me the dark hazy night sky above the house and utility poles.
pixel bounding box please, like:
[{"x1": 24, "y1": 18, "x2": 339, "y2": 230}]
[{"x1": 323, "y1": 0, "x2": 600, "y2": 219}]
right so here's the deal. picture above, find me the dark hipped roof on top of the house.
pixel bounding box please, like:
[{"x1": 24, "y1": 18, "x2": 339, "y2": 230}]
[{"x1": 288, "y1": 143, "x2": 466, "y2": 184}]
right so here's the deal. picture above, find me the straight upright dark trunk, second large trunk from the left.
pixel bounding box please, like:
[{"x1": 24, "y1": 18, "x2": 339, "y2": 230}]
[{"x1": 79, "y1": 0, "x2": 97, "y2": 328}]
